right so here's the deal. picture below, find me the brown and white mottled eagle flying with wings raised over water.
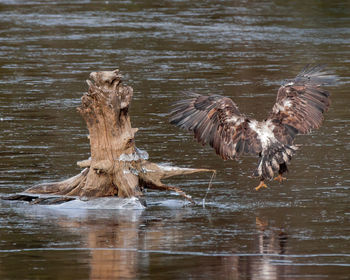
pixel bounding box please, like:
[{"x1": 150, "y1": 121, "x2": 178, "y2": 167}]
[{"x1": 170, "y1": 65, "x2": 336, "y2": 190}]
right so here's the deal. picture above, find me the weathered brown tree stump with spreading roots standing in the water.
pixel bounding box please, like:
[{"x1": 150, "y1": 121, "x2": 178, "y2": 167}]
[{"x1": 7, "y1": 70, "x2": 213, "y2": 203}]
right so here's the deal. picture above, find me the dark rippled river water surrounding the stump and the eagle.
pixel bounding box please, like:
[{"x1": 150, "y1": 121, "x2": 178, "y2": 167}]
[{"x1": 0, "y1": 0, "x2": 350, "y2": 280}]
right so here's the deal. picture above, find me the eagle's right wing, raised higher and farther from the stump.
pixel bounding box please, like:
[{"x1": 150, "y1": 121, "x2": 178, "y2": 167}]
[{"x1": 268, "y1": 65, "x2": 336, "y2": 144}]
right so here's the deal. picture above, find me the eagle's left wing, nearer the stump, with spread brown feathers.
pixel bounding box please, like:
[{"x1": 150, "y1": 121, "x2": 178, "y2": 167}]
[{"x1": 170, "y1": 93, "x2": 262, "y2": 159}]
